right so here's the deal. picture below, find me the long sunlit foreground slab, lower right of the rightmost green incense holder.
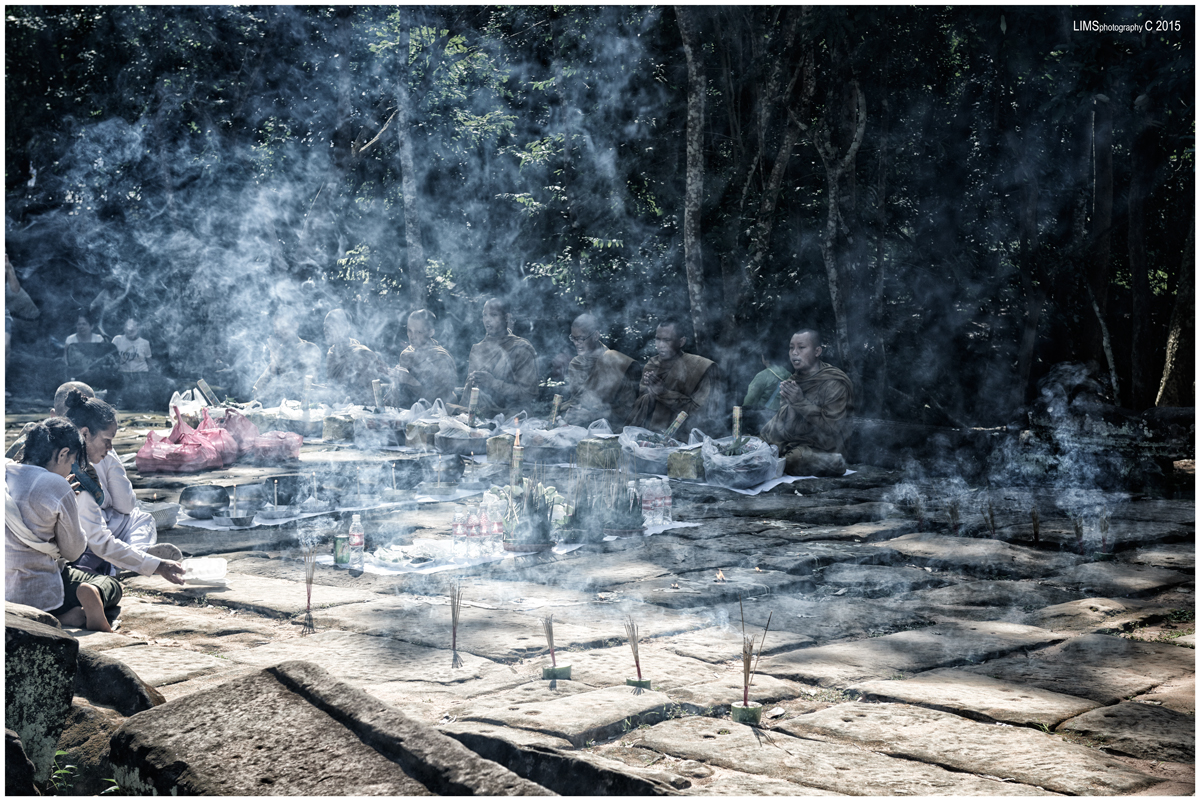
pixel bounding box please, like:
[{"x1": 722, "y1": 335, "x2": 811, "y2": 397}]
[{"x1": 779, "y1": 704, "x2": 1158, "y2": 795}]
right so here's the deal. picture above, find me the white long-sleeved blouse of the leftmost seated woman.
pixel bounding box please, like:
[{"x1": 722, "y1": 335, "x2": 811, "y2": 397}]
[{"x1": 4, "y1": 463, "x2": 87, "y2": 612}]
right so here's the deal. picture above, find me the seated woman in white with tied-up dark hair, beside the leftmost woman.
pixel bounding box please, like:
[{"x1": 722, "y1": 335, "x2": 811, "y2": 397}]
[{"x1": 60, "y1": 390, "x2": 184, "y2": 584}]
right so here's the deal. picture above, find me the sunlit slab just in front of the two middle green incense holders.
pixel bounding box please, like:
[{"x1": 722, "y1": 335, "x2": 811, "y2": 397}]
[{"x1": 460, "y1": 687, "x2": 671, "y2": 747}]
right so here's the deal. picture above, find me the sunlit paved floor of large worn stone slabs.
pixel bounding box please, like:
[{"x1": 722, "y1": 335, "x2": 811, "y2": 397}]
[{"x1": 7, "y1": 407, "x2": 1195, "y2": 795}]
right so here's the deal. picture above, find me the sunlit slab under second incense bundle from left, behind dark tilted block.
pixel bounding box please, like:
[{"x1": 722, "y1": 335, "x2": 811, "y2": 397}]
[{"x1": 228, "y1": 631, "x2": 493, "y2": 686}]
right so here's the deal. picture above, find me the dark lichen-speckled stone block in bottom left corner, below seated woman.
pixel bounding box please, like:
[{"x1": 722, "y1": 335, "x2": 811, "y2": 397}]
[{"x1": 4, "y1": 613, "x2": 79, "y2": 783}]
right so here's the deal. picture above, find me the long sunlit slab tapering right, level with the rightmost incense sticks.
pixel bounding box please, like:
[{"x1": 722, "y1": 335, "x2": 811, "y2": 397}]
[{"x1": 758, "y1": 621, "x2": 1063, "y2": 689}]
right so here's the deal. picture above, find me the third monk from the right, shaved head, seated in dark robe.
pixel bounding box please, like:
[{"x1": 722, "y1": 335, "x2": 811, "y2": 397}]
[{"x1": 563, "y1": 313, "x2": 641, "y2": 428}]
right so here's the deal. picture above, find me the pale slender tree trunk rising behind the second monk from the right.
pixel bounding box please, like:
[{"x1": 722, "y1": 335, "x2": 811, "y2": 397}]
[{"x1": 676, "y1": 6, "x2": 709, "y2": 350}]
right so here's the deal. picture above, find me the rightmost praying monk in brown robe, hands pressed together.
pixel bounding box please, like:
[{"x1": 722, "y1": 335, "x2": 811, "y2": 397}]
[{"x1": 761, "y1": 329, "x2": 854, "y2": 476}]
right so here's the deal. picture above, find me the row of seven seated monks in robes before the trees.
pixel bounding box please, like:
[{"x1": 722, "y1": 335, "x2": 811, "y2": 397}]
[{"x1": 254, "y1": 297, "x2": 853, "y2": 475}]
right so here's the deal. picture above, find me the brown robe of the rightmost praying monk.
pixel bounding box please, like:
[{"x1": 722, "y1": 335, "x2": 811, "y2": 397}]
[{"x1": 762, "y1": 362, "x2": 854, "y2": 476}]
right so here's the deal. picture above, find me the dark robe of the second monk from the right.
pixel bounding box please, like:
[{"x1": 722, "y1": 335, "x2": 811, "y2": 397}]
[{"x1": 625, "y1": 354, "x2": 724, "y2": 436}]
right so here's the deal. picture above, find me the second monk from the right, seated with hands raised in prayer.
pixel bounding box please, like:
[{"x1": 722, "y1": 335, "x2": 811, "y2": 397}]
[{"x1": 625, "y1": 319, "x2": 724, "y2": 439}]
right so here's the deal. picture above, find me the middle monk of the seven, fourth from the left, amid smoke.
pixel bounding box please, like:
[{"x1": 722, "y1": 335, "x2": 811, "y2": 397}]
[{"x1": 458, "y1": 297, "x2": 538, "y2": 417}]
